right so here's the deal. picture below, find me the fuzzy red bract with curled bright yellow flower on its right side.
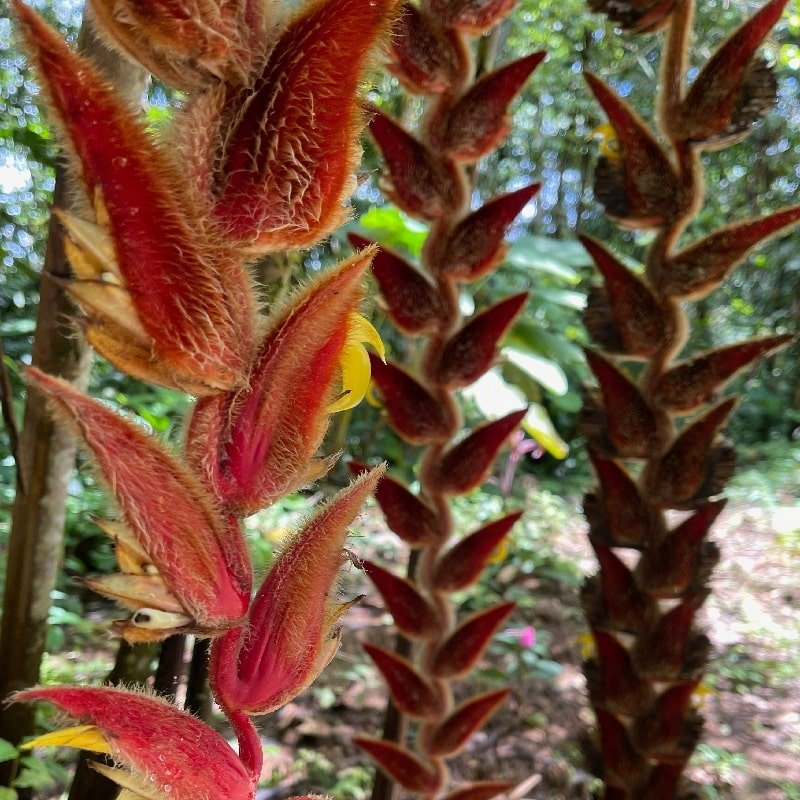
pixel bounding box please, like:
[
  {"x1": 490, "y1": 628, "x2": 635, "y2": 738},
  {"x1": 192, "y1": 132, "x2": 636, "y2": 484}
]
[{"x1": 186, "y1": 248, "x2": 383, "y2": 516}]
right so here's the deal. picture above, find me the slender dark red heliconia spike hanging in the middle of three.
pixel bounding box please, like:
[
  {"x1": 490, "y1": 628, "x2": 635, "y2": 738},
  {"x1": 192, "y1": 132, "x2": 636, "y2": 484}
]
[{"x1": 350, "y1": 0, "x2": 544, "y2": 800}]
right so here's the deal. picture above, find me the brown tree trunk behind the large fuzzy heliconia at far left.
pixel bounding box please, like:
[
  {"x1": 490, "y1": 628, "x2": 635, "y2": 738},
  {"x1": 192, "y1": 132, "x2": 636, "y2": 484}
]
[{"x1": 0, "y1": 12, "x2": 147, "y2": 785}]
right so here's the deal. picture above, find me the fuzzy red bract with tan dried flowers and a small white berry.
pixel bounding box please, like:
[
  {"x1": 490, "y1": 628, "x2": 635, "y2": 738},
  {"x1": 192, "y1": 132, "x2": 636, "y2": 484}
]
[{"x1": 26, "y1": 368, "x2": 252, "y2": 642}]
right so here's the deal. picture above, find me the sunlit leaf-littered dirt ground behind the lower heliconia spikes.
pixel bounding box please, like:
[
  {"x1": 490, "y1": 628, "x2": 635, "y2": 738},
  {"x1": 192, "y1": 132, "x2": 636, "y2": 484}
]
[{"x1": 260, "y1": 498, "x2": 800, "y2": 800}]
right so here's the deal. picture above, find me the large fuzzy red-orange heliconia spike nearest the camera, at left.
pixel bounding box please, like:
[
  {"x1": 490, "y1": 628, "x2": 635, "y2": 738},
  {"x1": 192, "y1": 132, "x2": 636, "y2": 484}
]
[{"x1": 12, "y1": 0, "x2": 404, "y2": 800}]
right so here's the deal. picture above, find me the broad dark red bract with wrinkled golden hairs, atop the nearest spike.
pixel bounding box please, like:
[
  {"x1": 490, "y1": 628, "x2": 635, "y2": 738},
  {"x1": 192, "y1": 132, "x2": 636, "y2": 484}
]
[{"x1": 215, "y1": 0, "x2": 395, "y2": 253}]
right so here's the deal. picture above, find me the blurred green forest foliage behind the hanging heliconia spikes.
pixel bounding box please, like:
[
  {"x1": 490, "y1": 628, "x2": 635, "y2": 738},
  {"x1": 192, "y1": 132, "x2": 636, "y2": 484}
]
[{"x1": 0, "y1": 0, "x2": 800, "y2": 798}]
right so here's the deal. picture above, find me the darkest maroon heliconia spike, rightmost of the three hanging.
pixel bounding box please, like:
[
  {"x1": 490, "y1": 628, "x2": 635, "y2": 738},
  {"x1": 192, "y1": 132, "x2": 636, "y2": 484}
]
[{"x1": 582, "y1": 0, "x2": 800, "y2": 800}]
